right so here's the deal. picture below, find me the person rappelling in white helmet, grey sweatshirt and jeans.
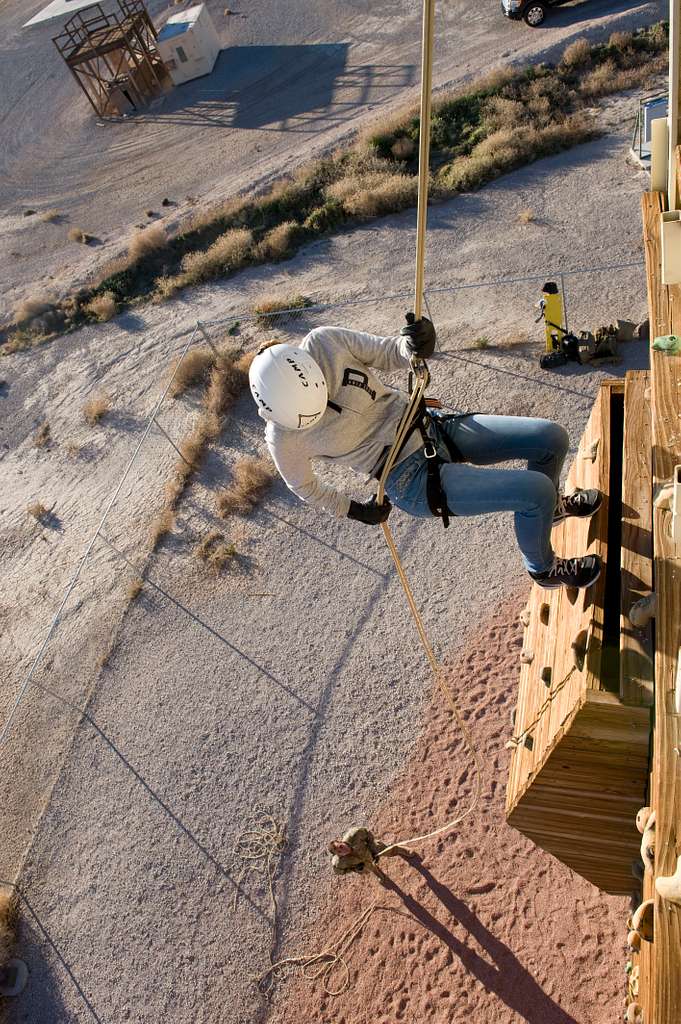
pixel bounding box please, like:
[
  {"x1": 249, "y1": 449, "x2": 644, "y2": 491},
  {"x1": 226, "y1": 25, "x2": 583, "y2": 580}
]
[{"x1": 249, "y1": 314, "x2": 601, "y2": 589}]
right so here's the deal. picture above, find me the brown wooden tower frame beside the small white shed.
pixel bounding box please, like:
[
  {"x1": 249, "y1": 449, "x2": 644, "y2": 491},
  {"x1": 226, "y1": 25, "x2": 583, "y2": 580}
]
[{"x1": 52, "y1": 0, "x2": 172, "y2": 118}]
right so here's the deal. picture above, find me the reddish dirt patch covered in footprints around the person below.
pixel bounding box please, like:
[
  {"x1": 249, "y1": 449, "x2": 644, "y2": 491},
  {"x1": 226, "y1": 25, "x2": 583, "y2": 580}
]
[{"x1": 269, "y1": 602, "x2": 628, "y2": 1024}]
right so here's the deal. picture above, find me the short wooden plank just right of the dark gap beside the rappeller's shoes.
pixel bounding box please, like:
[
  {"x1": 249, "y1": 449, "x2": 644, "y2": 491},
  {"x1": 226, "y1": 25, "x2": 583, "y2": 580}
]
[{"x1": 620, "y1": 370, "x2": 654, "y2": 706}]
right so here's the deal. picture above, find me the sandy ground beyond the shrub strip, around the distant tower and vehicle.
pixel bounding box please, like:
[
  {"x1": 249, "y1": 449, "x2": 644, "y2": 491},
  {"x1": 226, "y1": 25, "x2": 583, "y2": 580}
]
[{"x1": 0, "y1": 0, "x2": 666, "y2": 322}]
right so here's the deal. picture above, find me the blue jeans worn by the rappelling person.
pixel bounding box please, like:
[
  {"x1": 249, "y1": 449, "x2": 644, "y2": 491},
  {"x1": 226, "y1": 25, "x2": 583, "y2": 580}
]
[{"x1": 385, "y1": 414, "x2": 569, "y2": 572}]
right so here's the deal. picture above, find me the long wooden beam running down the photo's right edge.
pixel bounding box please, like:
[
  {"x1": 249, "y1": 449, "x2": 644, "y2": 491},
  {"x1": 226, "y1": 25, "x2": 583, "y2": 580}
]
[{"x1": 642, "y1": 194, "x2": 681, "y2": 1024}]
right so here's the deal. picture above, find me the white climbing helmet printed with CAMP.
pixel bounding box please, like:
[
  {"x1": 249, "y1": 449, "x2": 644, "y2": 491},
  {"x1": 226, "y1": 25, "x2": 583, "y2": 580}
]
[{"x1": 248, "y1": 344, "x2": 329, "y2": 430}]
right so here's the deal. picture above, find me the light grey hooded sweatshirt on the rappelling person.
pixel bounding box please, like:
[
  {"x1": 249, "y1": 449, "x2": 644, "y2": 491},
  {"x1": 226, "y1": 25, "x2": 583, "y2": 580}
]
[{"x1": 265, "y1": 327, "x2": 421, "y2": 516}]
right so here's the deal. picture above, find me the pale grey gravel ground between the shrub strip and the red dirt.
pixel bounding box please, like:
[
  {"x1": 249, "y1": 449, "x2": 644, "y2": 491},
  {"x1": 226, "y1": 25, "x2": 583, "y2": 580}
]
[{"x1": 0, "y1": 117, "x2": 645, "y2": 1024}]
